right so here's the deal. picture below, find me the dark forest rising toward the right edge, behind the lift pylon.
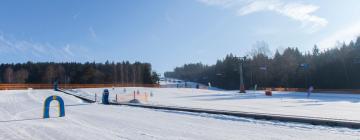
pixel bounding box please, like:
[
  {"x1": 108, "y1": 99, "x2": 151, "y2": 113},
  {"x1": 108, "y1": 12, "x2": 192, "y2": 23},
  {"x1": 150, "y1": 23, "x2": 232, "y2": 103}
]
[{"x1": 164, "y1": 37, "x2": 360, "y2": 89}]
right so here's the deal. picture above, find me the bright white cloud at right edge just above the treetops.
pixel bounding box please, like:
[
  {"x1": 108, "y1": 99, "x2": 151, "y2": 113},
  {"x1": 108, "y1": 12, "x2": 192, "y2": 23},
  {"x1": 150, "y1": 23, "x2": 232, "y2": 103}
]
[{"x1": 317, "y1": 21, "x2": 360, "y2": 49}]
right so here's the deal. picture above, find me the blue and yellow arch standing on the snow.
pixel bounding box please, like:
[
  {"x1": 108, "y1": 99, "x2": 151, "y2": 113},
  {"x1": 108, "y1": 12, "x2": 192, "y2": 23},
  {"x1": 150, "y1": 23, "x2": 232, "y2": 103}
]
[{"x1": 43, "y1": 95, "x2": 65, "y2": 118}]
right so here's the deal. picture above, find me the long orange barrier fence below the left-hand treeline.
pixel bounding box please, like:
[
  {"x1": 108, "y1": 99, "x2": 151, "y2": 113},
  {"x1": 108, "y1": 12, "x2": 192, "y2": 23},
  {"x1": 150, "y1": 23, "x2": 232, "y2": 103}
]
[{"x1": 0, "y1": 84, "x2": 160, "y2": 90}]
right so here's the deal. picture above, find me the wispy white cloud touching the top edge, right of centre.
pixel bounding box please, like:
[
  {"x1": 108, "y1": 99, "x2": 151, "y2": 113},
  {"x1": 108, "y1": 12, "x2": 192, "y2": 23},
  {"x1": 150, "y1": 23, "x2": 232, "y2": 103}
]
[{"x1": 199, "y1": 0, "x2": 328, "y2": 32}]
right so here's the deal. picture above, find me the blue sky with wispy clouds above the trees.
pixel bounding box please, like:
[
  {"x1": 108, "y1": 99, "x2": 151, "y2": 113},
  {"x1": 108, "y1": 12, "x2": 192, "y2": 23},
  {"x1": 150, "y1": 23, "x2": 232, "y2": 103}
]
[{"x1": 0, "y1": 0, "x2": 360, "y2": 73}]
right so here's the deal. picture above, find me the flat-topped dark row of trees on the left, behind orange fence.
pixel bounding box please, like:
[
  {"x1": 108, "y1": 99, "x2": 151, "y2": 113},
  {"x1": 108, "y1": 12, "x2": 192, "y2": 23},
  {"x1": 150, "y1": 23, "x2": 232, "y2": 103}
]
[{"x1": 0, "y1": 61, "x2": 159, "y2": 84}]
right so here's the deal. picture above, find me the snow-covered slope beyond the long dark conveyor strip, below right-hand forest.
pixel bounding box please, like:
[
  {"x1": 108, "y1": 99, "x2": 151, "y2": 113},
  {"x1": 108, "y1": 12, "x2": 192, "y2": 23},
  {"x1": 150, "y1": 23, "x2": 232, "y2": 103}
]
[{"x1": 80, "y1": 88, "x2": 360, "y2": 121}]
